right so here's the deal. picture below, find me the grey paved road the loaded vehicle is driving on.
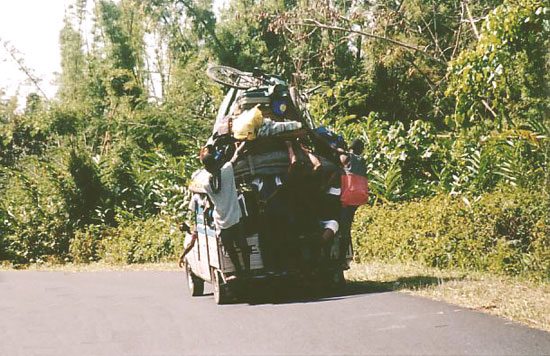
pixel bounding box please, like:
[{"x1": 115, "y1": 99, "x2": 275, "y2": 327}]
[{"x1": 0, "y1": 271, "x2": 550, "y2": 356}]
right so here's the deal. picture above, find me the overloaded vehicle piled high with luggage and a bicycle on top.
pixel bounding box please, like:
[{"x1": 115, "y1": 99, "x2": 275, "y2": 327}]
[{"x1": 181, "y1": 66, "x2": 353, "y2": 304}]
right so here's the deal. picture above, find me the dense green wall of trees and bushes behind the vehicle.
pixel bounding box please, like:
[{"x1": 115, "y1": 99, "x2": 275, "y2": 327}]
[{"x1": 0, "y1": 0, "x2": 550, "y2": 276}]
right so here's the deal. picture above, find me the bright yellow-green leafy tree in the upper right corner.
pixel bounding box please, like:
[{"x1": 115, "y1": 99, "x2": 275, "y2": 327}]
[{"x1": 447, "y1": 0, "x2": 550, "y2": 130}]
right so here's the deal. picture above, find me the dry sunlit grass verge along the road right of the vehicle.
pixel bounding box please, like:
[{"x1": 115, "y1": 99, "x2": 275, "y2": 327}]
[{"x1": 346, "y1": 262, "x2": 550, "y2": 331}]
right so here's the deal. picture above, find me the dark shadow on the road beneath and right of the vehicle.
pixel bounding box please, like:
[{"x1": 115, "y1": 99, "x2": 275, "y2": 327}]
[{"x1": 239, "y1": 276, "x2": 460, "y2": 305}]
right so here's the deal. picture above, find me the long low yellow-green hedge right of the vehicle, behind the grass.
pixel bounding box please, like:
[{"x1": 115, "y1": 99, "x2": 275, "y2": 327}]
[{"x1": 354, "y1": 189, "x2": 550, "y2": 280}]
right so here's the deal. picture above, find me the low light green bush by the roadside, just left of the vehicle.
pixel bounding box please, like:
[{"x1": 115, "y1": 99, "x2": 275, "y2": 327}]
[{"x1": 98, "y1": 218, "x2": 183, "y2": 264}]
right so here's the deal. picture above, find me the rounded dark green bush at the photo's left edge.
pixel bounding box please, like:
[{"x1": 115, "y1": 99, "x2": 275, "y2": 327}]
[{"x1": 0, "y1": 157, "x2": 73, "y2": 263}]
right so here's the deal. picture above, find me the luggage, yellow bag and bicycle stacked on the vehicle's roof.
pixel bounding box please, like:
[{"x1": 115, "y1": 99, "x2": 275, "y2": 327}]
[{"x1": 203, "y1": 67, "x2": 337, "y2": 178}]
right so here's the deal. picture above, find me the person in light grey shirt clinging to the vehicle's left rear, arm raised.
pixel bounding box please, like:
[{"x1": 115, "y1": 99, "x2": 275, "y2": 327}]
[{"x1": 200, "y1": 142, "x2": 250, "y2": 279}]
